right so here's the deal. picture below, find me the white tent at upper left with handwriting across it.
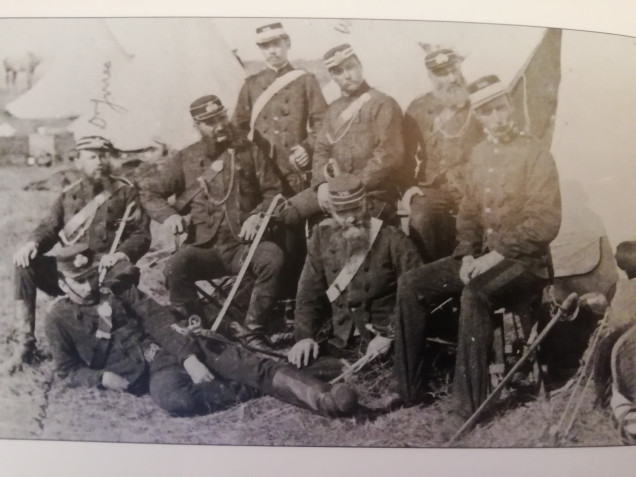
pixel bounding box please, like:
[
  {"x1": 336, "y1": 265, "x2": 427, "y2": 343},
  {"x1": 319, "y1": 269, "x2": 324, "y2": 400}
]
[{"x1": 7, "y1": 18, "x2": 244, "y2": 150}]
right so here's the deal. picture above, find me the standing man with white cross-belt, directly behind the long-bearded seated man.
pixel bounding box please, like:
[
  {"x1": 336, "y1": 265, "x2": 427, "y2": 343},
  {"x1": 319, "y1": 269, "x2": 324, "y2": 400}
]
[{"x1": 304, "y1": 44, "x2": 404, "y2": 219}]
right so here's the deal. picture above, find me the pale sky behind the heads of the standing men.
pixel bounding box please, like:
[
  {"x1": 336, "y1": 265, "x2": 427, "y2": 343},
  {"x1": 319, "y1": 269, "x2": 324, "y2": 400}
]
[{"x1": 217, "y1": 19, "x2": 545, "y2": 109}]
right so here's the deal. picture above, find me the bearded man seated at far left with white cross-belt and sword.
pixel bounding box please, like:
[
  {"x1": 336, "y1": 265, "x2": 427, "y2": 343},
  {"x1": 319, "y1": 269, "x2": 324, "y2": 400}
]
[{"x1": 9, "y1": 136, "x2": 151, "y2": 371}]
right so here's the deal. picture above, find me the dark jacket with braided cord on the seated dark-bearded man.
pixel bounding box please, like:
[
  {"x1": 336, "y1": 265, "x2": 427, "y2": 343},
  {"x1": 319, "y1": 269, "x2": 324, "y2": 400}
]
[{"x1": 142, "y1": 139, "x2": 281, "y2": 245}]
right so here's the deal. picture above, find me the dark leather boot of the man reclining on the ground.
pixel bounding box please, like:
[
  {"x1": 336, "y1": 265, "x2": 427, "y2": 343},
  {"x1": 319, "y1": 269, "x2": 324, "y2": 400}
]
[{"x1": 270, "y1": 367, "x2": 358, "y2": 417}]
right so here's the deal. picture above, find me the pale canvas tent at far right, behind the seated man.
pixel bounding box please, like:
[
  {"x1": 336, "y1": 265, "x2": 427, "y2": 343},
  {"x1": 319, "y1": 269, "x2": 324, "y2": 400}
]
[{"x1": 552, "y1": 31, "x2": 636, "y2": 247}]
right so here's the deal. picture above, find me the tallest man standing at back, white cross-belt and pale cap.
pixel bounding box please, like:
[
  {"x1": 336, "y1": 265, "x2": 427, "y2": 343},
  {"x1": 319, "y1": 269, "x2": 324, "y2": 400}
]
[{"x1": 233, "y1": 23, "x2": 327, "y2": 297}]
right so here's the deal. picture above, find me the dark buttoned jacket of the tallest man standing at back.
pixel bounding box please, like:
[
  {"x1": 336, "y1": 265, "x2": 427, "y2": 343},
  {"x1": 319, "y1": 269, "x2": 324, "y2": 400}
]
[{"x1": 232, "y1": 64, "x2": 327, "y2": 195}]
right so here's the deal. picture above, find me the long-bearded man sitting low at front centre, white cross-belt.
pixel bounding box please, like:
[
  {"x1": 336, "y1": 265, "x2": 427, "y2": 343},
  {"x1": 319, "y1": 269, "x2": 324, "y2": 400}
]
[{"x1": 288, "y1": 173, "x2": 420, "y2": 374}]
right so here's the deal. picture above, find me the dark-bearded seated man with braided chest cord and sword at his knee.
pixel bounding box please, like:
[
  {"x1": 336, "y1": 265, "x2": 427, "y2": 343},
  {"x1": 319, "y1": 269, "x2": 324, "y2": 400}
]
[{"x1": 142, "y1": 95, "x2": 283, "y2": 348}]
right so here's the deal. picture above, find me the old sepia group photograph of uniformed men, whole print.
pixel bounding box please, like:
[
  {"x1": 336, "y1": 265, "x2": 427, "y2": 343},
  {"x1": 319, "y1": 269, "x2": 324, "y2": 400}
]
[{"x1": 0, "y1": 18, "x2": 636, "y2": 448}]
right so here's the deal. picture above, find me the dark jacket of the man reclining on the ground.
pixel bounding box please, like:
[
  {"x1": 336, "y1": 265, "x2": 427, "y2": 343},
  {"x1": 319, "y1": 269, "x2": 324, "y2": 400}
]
[{"x1": 45, "y1": 290, "x2": 198, "y2": 386}]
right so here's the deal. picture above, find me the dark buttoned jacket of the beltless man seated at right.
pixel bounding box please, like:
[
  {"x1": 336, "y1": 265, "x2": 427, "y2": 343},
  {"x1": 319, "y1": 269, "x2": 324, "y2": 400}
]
[{"x1": 454, "y1": 130, "x2": 561, "y2": 278}]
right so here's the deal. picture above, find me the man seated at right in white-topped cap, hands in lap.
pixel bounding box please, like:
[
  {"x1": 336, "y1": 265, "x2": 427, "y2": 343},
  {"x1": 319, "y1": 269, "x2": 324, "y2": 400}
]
[{"x1": 396, "y1": 75, "x2": 561, "y2": 425}]
